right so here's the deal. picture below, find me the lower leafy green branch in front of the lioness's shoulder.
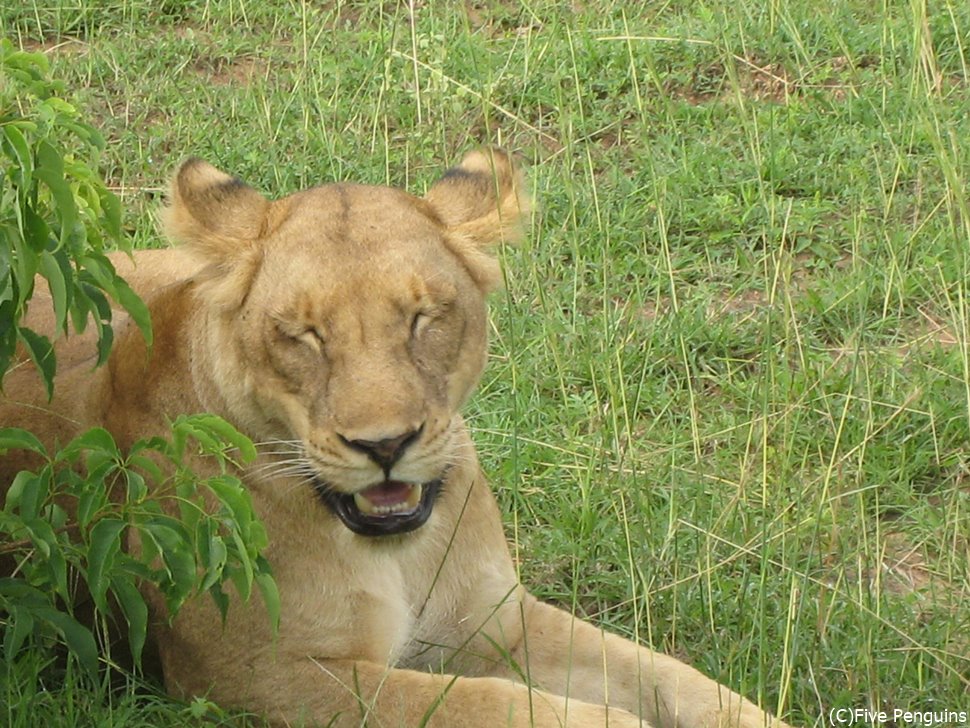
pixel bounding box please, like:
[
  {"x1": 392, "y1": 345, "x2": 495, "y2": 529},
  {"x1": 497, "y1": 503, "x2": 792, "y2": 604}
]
[{"x1": 0, "y1": 415, "x2": 279, "y2": 671}]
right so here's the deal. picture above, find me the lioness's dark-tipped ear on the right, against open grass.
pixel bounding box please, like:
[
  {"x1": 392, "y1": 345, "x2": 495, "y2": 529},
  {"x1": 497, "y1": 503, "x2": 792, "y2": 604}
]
[{"x1": 425, "y1": 148, "x2": 532, "y2": 289}]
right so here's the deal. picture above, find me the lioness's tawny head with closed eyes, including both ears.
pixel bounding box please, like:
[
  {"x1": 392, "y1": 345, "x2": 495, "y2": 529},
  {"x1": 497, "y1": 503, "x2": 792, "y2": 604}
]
[{"x1": 166, "y1": 152, "x2": 524, "y2": 536}]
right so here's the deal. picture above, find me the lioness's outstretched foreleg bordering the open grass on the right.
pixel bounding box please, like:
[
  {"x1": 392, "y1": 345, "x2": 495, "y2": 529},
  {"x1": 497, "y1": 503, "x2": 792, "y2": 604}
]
[{"x1": 496, "y1": 595, "x2": 787, "y2": 728}]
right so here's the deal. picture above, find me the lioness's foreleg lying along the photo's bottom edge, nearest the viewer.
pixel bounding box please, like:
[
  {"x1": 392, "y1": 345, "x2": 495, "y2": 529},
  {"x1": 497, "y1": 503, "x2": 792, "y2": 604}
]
[{"x1": 170, "y1": 656, "x2": 642, "y2": 728}]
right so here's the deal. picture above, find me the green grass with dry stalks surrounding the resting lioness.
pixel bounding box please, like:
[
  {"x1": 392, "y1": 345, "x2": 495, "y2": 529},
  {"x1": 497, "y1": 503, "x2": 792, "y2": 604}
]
[{"x1": 0, "y1": 0, "x2": 970, "y2": 725}]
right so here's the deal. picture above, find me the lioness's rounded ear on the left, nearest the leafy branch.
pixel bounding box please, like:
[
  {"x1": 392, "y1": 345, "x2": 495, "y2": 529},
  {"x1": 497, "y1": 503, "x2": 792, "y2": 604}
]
[{"x1": 161, "y1": 157, "x2": 272, "y2": 307}]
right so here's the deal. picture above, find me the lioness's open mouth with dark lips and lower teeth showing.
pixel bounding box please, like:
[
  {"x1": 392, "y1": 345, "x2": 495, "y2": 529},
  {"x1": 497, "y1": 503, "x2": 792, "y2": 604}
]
[{"x1": 314, "y1": 479, "x2": 441, "y2": 536}]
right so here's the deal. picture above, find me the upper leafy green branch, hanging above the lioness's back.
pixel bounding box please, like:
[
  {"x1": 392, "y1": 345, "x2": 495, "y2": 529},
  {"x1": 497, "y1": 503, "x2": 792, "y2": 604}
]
[{"x1": 0, "y1": 39, "x2": 151, "y2": 397}]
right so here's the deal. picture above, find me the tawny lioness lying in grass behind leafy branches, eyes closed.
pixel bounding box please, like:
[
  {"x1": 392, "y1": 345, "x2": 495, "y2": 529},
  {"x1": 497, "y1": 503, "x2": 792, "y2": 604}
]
[{"x1": 0, "y1": 150, "x2": 784, "y2": 728}]
